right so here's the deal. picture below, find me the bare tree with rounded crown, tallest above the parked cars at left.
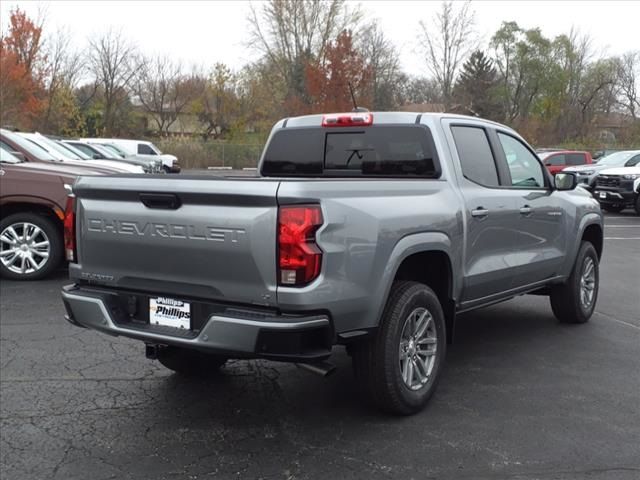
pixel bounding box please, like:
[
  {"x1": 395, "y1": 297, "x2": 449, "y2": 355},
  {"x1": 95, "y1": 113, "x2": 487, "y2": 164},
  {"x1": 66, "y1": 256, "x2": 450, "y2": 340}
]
[{"x1": 89, "y1": 30, "x2": 138, "y2": 135}]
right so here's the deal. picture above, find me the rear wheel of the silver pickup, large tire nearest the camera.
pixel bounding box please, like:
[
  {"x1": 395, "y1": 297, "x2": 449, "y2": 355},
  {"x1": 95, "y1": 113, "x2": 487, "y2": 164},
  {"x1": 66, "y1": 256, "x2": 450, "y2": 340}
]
[{"x1": 353, "y1": 281, "x2": 447, "y2": 415}]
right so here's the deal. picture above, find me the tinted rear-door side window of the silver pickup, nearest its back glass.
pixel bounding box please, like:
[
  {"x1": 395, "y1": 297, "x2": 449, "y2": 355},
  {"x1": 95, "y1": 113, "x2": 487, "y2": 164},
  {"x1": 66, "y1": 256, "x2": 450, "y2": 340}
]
[{"x1": 451, "y1": 126, "x2": 500, "y2": 187}]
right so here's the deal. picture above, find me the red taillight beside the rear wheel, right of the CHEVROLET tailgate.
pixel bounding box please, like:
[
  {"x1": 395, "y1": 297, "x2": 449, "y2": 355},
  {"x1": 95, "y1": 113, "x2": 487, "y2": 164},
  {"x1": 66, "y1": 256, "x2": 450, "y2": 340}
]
[{"x1": 278, "y1": 205, "x2": 323, "y2": 287}]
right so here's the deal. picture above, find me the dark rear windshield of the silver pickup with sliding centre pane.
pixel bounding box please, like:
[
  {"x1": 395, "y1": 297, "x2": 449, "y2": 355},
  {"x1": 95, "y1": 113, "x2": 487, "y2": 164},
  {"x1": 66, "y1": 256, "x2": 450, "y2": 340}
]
[{"x1": 262, "y1": 125, "x2": 440, "y2": 178}]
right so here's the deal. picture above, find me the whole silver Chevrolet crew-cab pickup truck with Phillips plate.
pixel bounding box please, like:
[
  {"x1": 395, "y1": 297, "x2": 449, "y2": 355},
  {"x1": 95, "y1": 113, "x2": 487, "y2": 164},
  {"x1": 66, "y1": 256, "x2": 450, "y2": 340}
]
[{"x1": 62, "y1": 112, "x2": 603, "y2": 414}]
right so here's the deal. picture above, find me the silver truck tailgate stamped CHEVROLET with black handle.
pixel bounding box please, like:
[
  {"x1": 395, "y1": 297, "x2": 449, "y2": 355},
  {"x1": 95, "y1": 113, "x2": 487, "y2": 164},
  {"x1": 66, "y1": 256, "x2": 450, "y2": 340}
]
[{"x1": 70, "y1": 176, "x2": 279, "y2": 305}]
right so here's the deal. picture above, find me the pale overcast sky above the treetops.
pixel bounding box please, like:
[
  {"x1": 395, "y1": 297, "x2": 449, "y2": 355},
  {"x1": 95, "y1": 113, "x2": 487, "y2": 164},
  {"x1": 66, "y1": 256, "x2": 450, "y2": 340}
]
[{"x1": 0, "y1": 0, "x2": 640, "y2": 75}]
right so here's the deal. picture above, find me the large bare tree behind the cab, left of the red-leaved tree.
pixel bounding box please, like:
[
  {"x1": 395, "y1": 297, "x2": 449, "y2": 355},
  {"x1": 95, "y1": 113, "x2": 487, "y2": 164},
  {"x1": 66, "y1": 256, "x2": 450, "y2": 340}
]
[{"x1": 248, "y1": 0, "x2": 360, "y2": 101}]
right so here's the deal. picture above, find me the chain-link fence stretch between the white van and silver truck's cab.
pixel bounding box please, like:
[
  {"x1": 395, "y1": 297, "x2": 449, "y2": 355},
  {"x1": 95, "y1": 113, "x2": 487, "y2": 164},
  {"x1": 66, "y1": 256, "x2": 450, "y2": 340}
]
[{"x1": 155, "y1": 139, "x2": 263, "y2": 170}]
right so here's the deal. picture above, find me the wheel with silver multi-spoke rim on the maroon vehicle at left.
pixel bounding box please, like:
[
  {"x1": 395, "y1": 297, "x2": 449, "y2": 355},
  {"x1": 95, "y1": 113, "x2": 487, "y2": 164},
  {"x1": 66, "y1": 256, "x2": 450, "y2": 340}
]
[{"x1": 0, "y1": 212, "x2": 64, "y2": 280}]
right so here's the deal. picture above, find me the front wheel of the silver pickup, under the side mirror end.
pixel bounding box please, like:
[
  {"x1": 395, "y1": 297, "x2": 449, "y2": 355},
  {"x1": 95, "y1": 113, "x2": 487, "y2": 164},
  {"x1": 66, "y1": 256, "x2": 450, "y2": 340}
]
[{"x1": 549, "y1": 242, "x2": 600, "y2": 323}]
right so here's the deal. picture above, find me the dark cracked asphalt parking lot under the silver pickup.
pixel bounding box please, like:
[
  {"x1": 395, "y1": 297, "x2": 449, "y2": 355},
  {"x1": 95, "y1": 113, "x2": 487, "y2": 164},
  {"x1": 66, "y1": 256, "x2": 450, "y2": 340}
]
[{"x1": 0, "y1": 211, "x2": 640, "y2": 480}]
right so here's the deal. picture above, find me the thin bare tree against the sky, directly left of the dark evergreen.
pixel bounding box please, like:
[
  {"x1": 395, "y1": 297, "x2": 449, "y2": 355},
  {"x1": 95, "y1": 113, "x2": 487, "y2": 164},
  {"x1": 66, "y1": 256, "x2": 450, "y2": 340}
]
[{"x1": 420, "y1": 1, "x2": 475, "y2": 109}]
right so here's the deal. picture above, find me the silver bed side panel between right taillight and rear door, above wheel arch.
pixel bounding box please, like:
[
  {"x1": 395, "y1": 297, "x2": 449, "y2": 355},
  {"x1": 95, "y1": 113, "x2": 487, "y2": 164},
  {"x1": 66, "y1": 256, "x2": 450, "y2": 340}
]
[{"x1": 278, "y1": 179, "x2": 462, "y2": 332}]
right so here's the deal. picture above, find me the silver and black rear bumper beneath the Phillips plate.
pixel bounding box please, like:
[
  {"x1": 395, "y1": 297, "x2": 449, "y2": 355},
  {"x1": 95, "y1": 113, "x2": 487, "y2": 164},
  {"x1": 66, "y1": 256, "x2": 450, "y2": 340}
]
[{"x1": 62, "y1": 285, "x2": 333, "y2": 362}]
